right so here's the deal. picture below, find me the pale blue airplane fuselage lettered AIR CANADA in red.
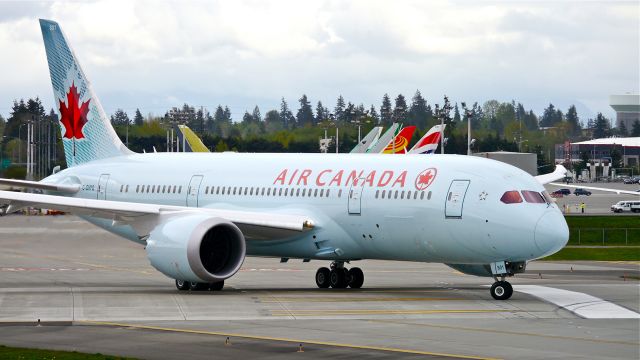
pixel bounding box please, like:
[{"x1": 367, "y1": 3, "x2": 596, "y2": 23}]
[{"x1": 45, "y1": 153, "x2": 567, "y2": 264}]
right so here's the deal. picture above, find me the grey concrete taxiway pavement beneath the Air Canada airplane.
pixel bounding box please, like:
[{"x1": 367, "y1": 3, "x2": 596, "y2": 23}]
[{"x1": 0, "y1": 216, "x2": 640, "y2": 359}]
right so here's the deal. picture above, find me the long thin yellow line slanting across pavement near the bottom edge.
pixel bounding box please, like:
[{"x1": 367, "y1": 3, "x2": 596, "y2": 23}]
[{"x1": 79, "y1": 321, "x2": 498, "y2": 360}]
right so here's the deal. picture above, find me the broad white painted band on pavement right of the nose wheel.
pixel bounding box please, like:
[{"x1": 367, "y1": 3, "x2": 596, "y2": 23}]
[{"x1": 513, "y1": 285, "x2": 640, "y2": 319}]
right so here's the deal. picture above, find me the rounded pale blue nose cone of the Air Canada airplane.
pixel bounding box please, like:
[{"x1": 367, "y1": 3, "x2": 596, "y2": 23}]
[{"x1": 534, "y1": 212, "x2": 569, "y2": 257}]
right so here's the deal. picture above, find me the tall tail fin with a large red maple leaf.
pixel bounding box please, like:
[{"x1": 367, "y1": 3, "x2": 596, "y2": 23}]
[{"x1": 40, "y1": 19, "x2": 131, "y2": 167}]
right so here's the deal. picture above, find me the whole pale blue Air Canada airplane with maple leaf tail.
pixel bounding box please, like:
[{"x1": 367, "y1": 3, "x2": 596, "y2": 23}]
[{"x1": 0, "y1": 20, "x2": 569, "y2": 300}]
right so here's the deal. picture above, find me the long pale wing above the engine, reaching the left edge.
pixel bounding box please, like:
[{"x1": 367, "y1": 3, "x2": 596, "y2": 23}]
[{"x1": 0, "y1": 191, "x2": 314, "y2": 238}]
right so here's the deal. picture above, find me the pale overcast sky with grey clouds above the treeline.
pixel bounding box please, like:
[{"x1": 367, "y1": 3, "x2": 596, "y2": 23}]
[{"x1": 0, "y1": 0, "x2": 640, "y2": 120}]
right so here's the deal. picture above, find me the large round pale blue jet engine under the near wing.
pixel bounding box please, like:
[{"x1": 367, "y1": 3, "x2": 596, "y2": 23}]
[{"x1": 146, "y1": 215, "x2": 246, "y2": 283}]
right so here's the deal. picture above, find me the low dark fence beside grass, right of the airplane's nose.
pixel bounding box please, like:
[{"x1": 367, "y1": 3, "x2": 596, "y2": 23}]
[{"x1": 569, "y1": 228, "x2": 640, "y2": 246}]
